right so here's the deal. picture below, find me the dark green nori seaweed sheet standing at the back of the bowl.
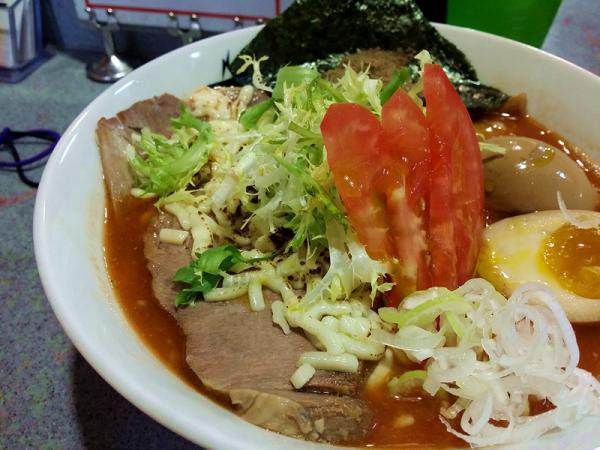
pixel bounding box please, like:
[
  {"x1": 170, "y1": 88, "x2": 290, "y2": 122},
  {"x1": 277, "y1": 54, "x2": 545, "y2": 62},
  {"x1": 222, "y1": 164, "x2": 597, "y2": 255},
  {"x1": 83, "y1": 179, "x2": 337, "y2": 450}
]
[{"x1": 229, "y1": 0, "x2": 508, "y2": 112}]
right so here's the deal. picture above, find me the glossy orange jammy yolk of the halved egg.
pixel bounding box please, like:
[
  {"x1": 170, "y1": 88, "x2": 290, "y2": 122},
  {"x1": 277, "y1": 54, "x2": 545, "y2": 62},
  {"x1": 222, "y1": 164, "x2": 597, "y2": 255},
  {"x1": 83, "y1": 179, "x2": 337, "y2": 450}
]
[{"x1": 541, "y1": 224, "x2": 600, "y2": 299}]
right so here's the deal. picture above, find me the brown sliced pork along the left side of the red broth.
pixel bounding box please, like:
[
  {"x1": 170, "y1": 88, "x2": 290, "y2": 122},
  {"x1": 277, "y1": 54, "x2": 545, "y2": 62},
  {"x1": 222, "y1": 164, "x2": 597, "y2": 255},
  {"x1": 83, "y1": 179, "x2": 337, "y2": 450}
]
[{"x1": 96, "y1": 88, "x2": 372, "y2": 442}]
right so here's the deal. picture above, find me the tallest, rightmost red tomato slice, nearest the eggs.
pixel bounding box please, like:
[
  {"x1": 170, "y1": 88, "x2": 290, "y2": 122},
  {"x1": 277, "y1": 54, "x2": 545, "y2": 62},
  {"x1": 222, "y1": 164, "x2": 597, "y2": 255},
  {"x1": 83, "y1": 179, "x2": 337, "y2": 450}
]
[{"x1": 423, "y1": 64, "x2": 484, "y2": 288}]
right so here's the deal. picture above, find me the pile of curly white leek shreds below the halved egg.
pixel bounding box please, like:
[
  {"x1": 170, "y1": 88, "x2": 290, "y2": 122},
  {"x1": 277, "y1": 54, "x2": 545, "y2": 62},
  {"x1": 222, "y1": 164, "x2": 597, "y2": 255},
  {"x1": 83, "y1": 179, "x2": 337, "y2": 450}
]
[{"x1": 380, "y1": 279, "x2": 600, "y2": 446}]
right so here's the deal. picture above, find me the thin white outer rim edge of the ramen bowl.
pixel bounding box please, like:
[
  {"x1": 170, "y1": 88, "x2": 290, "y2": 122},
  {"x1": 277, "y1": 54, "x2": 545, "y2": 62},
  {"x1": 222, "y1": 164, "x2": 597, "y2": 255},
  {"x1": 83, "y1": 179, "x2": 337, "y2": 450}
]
[{"x1": 33, "y1": 23, "x2": 600, "y2": 448}]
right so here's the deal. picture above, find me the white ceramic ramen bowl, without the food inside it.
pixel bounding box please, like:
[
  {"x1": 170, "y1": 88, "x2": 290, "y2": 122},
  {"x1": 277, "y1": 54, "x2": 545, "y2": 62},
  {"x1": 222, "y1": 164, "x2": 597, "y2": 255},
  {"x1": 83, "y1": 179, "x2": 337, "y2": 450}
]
[{"x1": 34, "y1": 25, "x2": 600, "y2": 450}]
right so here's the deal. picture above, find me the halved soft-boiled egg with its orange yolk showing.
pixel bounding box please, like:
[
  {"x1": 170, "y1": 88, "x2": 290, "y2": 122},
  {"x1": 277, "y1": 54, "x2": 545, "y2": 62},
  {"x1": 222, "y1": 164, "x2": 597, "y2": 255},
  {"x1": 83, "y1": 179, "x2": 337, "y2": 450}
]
[{"x1": 477, "y1": 211, "x2": 600, "y2": 322}]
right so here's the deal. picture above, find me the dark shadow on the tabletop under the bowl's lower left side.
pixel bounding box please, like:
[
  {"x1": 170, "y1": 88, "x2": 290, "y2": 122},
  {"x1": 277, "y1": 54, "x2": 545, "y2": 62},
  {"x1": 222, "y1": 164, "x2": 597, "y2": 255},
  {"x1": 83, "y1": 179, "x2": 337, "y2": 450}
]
[{"x1": 72, "y1": 352, "x2": 199, "y2": 450}]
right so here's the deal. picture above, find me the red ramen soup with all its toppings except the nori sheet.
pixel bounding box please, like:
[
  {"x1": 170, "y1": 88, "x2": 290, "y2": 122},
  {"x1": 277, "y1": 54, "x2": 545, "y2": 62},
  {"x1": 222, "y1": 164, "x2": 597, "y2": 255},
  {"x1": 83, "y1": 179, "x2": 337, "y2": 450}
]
[{"x1": 97, "y1": 53, "x2": 600, "y2": 447}]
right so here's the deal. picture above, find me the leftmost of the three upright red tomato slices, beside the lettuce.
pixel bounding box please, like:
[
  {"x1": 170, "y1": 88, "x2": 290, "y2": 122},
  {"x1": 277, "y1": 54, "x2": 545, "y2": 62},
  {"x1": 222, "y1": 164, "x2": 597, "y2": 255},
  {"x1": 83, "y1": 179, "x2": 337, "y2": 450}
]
[{"x1": 321, "y1": 103, "x2": 393, "y2": 260}]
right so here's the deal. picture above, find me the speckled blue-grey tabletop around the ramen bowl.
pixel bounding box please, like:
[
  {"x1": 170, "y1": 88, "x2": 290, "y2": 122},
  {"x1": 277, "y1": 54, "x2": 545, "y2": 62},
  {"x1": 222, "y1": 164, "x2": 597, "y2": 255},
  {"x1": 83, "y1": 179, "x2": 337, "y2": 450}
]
[{"x1": 0, "y1": 0, "x2": 600, "y2": 449}]
